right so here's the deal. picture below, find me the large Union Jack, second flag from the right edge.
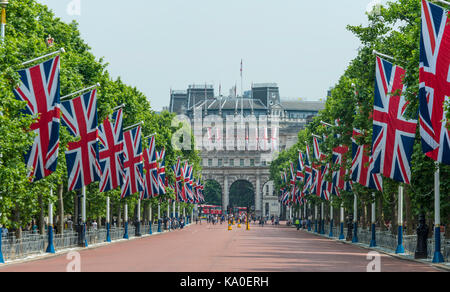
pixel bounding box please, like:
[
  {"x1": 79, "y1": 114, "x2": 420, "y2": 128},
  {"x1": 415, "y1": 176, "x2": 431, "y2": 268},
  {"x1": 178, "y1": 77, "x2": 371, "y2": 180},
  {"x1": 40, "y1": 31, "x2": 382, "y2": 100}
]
[{"x1": 372, "y1": 57, "x2": 417, "y2": 184}]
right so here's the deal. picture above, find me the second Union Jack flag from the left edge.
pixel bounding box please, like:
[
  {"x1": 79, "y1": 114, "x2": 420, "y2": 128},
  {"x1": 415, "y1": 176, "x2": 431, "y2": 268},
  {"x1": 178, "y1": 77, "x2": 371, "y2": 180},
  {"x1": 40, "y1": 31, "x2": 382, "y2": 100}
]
[{"x1": 61, "y1": 89, "x2": 101, "y2": 191}]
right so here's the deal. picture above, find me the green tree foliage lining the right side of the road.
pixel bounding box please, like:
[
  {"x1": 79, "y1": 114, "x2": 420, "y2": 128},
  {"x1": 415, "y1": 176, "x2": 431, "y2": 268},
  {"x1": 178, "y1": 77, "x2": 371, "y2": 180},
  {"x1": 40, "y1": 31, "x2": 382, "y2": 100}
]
[{"x1": 271, "y1": 0, "x2": 450, "y2": 231}]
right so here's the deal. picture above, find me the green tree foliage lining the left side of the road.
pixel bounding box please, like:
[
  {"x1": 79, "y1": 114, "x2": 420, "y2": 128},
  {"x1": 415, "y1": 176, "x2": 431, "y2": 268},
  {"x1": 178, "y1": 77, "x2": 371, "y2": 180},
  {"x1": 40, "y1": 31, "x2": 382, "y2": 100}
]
[{"x1": 0, "y1": 0, "x2": 201, "y2": 233}]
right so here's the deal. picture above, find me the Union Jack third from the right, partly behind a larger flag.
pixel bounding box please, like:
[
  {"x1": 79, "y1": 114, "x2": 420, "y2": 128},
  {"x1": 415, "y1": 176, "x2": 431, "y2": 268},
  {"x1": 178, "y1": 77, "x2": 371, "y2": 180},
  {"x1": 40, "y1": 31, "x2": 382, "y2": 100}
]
[{"x1": 352, "y1": 129, "x2": 383, "y2": 191}]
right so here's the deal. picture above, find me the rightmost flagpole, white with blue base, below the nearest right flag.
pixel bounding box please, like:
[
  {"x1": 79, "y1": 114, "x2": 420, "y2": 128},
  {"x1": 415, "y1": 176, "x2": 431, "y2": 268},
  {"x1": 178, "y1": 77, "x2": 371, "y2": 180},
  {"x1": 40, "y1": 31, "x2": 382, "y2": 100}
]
[{"x1": 433, "y1": 162, "x2": 444, "y2": 263}]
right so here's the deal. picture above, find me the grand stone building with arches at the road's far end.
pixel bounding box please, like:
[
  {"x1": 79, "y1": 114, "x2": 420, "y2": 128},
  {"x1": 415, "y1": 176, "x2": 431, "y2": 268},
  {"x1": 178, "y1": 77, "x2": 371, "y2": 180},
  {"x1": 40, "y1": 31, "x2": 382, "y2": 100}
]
[{"x1": 169, "y1": 83, "x2": 325, "y2": 217}]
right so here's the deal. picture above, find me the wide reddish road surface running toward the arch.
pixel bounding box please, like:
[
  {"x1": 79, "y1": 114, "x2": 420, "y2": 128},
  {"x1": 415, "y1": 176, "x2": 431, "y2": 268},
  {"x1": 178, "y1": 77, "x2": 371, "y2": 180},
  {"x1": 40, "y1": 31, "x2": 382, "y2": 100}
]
[{"x1": 0, "y1": 223, "x2": 437, "y2": 272}]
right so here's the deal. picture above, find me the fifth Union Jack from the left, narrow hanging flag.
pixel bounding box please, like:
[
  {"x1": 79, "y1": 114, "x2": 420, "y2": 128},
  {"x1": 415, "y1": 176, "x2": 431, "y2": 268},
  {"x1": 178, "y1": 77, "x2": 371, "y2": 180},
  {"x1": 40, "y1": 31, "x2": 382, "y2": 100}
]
[{"x1": 141, "y1": 136, "x2": 159, "y2": 199}]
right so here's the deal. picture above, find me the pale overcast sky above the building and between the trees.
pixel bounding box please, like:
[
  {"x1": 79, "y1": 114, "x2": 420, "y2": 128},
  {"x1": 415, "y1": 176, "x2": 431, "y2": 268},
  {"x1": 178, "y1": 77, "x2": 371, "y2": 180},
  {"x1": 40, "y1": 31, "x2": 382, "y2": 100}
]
[{"x1": 38, "y1": 0, "x2": 386, "y2": 110}]
